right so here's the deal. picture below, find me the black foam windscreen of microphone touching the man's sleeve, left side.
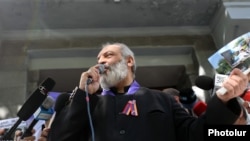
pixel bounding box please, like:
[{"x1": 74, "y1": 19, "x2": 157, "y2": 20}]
[{"x1": 54, "y1": 93, "x2": 70, "y2": 113}]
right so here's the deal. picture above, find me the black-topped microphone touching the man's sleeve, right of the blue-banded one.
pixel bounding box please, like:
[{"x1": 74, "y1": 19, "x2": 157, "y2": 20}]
[{"x1": 48, "y1": 93, "x2": 70, "y2": 128}]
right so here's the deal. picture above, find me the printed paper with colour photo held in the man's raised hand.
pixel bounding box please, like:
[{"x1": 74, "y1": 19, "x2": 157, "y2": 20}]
[{"x1": 208, "y1": 32, "x2": 250, "y2": 95}]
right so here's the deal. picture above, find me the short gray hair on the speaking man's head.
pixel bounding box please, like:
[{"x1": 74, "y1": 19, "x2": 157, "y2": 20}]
[{"x1": 102, "y1": 42, "x2": 136, "y2": 77}]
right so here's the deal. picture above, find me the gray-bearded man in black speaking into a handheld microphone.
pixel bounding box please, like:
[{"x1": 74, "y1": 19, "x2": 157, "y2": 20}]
[{"x1": 40, "y1": 43, "x2": 248, "y2": 141}]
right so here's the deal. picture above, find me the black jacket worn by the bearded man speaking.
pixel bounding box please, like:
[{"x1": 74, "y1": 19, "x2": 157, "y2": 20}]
[{"x1": 48, "y1": 87, "x2": 240, "y2": 141}]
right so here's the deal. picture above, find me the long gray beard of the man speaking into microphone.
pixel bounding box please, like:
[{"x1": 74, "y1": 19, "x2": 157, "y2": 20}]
[{"x1": 99, "y1": 59, "x2": 128, "y2": 90}]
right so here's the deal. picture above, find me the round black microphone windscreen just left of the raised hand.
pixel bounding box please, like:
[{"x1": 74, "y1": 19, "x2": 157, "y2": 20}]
[{"x1": 195, "y1": 75, "x2": 214, "y2": 90}]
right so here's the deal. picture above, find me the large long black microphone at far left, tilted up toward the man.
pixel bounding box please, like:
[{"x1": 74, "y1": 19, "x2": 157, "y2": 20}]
[{"x1": 1, "y1": 78, "x2": 55, "y2": 140}]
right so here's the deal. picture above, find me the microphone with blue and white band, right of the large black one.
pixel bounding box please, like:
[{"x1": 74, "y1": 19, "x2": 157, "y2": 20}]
[{"x1": 21, "y1": 96, "x2": 55, "y2": 139}]
